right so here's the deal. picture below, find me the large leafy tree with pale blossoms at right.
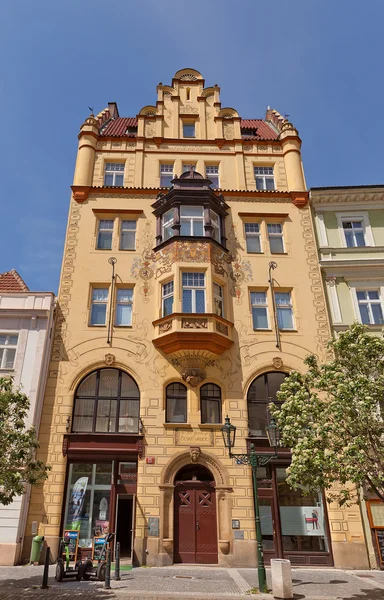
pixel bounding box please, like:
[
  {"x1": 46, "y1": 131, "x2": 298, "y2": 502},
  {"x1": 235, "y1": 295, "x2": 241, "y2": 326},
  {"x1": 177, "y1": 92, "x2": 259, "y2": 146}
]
[{"x1": 270, "y1": 323, "x2": 384, "y2": 505}]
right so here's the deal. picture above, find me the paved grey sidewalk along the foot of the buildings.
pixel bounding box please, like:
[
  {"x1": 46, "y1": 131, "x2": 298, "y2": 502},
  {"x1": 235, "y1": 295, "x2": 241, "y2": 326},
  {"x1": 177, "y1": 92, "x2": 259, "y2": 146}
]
[{"x1": 0, "y1": 565, "x2": 384, "y2": 600}]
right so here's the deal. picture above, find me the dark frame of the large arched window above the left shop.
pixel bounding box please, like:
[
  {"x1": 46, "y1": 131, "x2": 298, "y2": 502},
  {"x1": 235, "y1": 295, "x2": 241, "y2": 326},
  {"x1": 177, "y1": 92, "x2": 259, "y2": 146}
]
[{"x1": 71, "y1": 367, "x2": 141, "y2": 435}]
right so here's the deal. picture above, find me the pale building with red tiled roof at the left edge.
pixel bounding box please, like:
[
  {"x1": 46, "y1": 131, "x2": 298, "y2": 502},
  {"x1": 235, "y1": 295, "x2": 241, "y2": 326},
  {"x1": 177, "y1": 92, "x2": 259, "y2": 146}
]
[{"x1": 0, "y1": 269, "x2": 55, "y2": 565}]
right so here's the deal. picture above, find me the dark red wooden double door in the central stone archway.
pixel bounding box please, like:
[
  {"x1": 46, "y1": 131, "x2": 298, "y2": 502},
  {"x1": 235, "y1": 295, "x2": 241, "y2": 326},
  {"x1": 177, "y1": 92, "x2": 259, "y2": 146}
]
[{"x1": 174, "y1": 464, "x2": 218, "y2": 564}]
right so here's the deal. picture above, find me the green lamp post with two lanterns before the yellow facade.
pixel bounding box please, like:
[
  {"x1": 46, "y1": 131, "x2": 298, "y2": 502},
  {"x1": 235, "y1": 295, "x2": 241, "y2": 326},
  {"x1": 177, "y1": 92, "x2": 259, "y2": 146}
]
[{"x1": 221, "y1": 415, "x2": 280, "y2": 592}]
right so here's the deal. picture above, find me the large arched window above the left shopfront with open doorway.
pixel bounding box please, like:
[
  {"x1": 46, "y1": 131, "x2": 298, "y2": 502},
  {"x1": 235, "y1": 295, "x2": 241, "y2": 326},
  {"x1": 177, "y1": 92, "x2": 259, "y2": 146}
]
[{"x1": 72, "y1": 369, "x2": 140, "y2": 433}]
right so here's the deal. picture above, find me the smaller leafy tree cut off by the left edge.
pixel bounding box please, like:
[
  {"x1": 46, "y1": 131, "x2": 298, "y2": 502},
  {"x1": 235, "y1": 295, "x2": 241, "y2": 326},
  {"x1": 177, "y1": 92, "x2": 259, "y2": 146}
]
[{"x1": 0, "y1": 377, "x2": 50, "y2": 504}]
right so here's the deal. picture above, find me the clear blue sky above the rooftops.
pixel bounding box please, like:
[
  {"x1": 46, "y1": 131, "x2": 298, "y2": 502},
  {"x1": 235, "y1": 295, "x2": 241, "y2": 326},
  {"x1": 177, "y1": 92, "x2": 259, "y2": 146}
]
[{"x1": 0, "y1": 0, "x2": 384, "y2": 292}]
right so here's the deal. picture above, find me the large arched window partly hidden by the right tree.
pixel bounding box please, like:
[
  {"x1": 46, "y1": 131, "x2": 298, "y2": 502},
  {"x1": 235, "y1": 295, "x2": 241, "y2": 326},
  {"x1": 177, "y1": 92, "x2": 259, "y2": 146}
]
[{"x1": 247, "y1": 371, "x2": 287, "y2": 437}]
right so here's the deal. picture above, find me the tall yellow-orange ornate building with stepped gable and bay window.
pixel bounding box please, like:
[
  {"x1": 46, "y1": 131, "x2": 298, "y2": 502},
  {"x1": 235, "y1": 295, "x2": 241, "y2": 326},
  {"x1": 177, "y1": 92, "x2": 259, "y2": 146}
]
[{"x1": 24, "y1": 69, "x2": 367, "y2": 567}]
